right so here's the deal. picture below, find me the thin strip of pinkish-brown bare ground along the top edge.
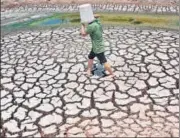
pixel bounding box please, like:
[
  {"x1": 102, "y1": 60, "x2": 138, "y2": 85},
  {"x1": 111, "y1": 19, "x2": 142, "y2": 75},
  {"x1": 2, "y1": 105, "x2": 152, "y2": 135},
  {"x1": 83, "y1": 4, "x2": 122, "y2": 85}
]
[{"x1": 1, "y1": 0, "x2": 178, "y2": 8}]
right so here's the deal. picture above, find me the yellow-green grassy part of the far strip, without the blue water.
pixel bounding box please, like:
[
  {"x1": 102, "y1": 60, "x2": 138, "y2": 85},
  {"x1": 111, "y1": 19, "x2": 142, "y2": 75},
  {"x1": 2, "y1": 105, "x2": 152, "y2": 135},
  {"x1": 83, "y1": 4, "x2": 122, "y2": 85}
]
[{"x1": 57, "y1": 13, "x2": 179, "y2": 29}]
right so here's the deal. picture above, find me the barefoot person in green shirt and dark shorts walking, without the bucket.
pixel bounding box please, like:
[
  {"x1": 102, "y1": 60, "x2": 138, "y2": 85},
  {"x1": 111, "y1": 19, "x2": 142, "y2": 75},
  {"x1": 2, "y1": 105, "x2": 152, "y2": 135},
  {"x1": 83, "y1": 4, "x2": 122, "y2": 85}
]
[{"x1": 81, "y1": 4, "x2": 115, "y2": 77}]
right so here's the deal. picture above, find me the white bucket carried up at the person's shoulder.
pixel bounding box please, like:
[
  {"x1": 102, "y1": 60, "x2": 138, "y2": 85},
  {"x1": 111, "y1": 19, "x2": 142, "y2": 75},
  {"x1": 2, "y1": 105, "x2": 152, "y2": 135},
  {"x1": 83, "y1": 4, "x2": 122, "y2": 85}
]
[{"x1": 79, "y1": 4, "x2": 95, "y2": 23}]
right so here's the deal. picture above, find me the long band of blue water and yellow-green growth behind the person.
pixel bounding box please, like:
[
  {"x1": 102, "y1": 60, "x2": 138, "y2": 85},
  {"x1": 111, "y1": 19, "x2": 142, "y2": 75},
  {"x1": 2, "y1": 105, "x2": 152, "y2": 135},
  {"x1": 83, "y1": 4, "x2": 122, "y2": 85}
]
[{"x1": 2, "y1": 13, "x2": 179, "y2": 31}]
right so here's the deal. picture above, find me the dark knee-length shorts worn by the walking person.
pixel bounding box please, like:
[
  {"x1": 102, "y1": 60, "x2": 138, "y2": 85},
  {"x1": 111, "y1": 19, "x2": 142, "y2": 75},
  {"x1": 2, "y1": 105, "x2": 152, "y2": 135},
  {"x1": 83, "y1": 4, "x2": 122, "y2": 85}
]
[{"x1": 88, "y1": 50, "x2": 107, "y2": 64}]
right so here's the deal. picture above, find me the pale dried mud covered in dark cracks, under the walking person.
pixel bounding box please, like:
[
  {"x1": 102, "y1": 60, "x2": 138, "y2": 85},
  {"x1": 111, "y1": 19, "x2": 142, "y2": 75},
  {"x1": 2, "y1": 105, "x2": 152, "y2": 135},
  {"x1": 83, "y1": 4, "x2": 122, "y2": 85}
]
[{"x1": 1, "y1": 27, "x2": 179, "y2": 137}]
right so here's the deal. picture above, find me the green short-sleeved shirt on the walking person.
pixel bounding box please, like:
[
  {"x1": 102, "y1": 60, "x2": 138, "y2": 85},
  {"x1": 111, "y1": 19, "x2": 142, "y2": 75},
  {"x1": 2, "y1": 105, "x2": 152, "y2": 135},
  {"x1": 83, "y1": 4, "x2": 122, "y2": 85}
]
[{"x1": 86, "y1": 19, "x2": 105, "y2": 54}]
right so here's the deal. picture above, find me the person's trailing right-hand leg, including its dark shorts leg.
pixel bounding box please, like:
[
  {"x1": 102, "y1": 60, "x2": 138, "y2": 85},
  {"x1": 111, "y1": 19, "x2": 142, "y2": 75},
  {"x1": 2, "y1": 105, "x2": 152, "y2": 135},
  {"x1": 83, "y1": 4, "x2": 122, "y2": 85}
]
[{"x1": 97, "y1": 52, "x2": 115, "y2": 77}]
